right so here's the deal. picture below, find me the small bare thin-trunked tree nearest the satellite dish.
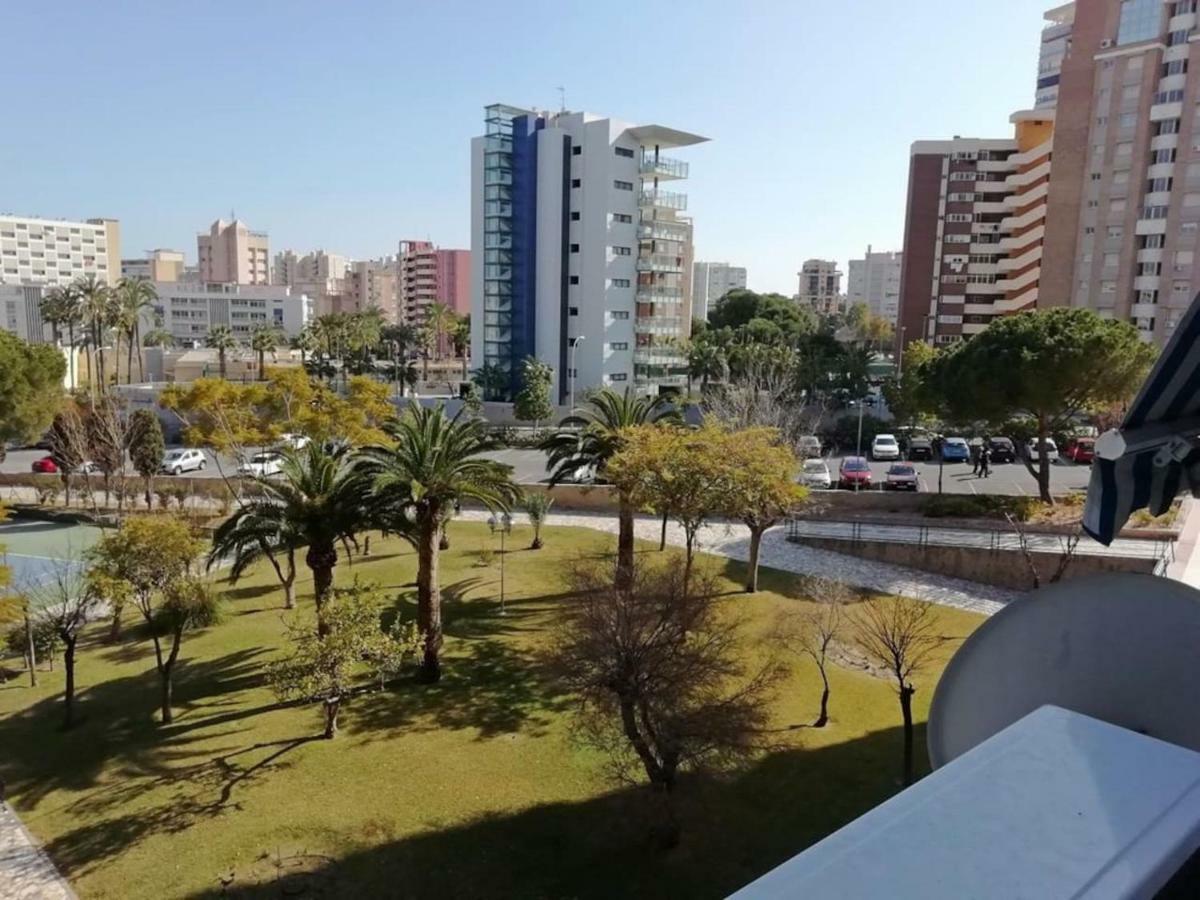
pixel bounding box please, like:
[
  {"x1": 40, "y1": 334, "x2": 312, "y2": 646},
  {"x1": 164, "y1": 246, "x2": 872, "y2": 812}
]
[{"x1": 850, "y1": 596, "x2": 946, "y2": 786}]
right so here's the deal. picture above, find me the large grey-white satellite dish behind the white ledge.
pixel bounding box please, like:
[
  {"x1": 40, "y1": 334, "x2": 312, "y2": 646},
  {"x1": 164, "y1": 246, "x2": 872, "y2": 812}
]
[{"x1": 928, "y1": 574, "x2": 1200, "y2": 768}]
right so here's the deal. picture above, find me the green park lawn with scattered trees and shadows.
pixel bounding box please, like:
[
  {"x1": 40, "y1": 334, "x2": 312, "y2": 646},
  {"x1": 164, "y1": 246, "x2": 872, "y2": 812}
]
[{"x1": 0, "y1": 523, "x2": 979, "y2": 900}]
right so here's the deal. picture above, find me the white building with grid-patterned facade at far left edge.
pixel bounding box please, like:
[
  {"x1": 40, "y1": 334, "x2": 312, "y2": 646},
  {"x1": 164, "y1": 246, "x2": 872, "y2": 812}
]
[{"x1": 0, "y1": 215, "x2": 121, "y2": 287}]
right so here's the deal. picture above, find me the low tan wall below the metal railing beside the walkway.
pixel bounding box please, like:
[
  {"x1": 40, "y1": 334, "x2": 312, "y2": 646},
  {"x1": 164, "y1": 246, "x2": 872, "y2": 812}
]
[{"x1": 792, "y1": 538, "x2": 1157, "y2": 590}]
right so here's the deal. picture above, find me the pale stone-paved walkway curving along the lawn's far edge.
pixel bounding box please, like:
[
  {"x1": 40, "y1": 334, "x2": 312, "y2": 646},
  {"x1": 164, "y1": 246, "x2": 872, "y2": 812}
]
[{"x1": 461, "y1": 510, "x2": 1020, "y2": 616}]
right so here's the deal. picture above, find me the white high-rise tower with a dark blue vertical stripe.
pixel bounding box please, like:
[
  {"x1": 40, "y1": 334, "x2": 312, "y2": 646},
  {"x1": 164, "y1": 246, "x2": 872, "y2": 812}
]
[{"x1": 470, "y1": 104, "x2": 704, "y2": 403}]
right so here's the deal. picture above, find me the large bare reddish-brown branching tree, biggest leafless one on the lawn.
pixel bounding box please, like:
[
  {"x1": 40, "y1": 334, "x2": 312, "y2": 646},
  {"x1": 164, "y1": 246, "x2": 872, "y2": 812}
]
[{"x1": 551, "y1": 562, "x2": 781, "y2": 846}]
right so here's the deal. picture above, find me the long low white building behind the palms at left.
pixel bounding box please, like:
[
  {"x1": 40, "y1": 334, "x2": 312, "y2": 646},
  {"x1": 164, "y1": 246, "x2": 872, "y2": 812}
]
[{"x1": 142, "y1": 282, "x2": 314, "y2": 344}]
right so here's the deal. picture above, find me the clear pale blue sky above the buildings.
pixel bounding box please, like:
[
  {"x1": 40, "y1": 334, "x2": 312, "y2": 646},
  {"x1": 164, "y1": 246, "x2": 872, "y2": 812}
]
[{"x1": 0, "y1": 0, "x2": 1054, "y2": 294}]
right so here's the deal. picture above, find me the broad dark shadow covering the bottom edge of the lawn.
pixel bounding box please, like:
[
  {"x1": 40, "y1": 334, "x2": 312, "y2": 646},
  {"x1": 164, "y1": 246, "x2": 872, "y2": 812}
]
[{"x1": 193, "y1": 728, "x2": 924, "y2": 900}]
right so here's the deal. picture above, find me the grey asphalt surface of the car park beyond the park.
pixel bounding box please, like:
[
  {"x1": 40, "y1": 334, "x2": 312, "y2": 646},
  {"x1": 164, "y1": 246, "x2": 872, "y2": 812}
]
[{"x1": 0, "y1": 450, "x2": 1091, "y2": 496}]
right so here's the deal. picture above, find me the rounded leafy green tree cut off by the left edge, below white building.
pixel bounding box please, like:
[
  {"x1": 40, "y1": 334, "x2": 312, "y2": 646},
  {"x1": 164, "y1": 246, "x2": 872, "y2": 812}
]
[{"x1": 0, "y1": 331, "x2": 66, "y2": 458}]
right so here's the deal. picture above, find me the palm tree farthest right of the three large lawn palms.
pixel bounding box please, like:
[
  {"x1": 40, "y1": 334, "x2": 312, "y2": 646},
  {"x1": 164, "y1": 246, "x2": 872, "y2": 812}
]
[{"x1": 541, "y1": 388, "x2": 682, "y2": 588}]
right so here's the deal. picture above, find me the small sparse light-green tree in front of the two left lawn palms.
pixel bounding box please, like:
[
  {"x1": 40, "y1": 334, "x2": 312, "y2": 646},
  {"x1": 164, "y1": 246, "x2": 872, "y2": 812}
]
[{"x1": 268, "y1": 583, "x2": 416, "y2": 740}]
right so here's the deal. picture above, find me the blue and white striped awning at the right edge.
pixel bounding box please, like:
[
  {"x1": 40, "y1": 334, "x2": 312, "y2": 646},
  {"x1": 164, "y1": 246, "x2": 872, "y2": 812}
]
[{"x1": 1084, "y1": 300, "x2": 1200, "y2": 544}]
